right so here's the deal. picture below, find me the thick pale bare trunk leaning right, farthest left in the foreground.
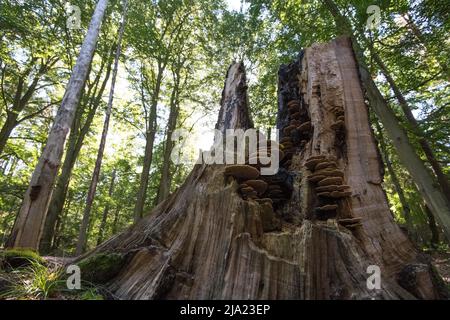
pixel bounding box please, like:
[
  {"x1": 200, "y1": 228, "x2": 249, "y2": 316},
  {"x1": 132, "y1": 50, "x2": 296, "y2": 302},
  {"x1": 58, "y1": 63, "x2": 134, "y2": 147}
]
[{"x1": 8, "y1": 0, "x2": 108, "y2": 250}]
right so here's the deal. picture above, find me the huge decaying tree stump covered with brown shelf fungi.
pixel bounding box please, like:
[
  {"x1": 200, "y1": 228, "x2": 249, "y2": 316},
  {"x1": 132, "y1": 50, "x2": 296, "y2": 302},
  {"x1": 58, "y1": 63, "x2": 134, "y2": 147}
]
[{"x1": 82, "y1": 38, "x2": 442, "y2": 299}]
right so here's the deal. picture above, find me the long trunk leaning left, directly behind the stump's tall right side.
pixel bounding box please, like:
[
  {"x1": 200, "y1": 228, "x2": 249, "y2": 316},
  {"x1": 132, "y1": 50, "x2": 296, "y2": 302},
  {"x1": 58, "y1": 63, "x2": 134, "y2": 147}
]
[{"x1": 324, "y1": 0, "x2": 450, "y2": 241}]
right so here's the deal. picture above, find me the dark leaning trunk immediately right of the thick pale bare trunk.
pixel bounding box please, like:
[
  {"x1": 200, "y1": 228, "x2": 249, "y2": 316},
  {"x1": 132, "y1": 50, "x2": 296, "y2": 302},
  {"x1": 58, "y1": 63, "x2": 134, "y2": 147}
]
[{"x1": 39, "y1": 48, "x2": 113, "y2": 253}]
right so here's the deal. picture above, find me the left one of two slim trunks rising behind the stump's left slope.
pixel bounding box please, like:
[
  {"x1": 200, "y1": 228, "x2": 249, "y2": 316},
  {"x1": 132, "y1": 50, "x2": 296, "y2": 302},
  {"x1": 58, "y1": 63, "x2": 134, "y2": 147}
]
[{"x1": 134, "y1": 63, "x2": 164, "y2": 222}]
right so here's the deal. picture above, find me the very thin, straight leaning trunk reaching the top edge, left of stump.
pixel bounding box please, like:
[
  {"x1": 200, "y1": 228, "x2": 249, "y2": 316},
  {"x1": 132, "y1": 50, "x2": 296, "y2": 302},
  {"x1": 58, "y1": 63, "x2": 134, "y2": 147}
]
[{"x1": 75, "y1": 0, "x2": 128, "y2": 255}]
